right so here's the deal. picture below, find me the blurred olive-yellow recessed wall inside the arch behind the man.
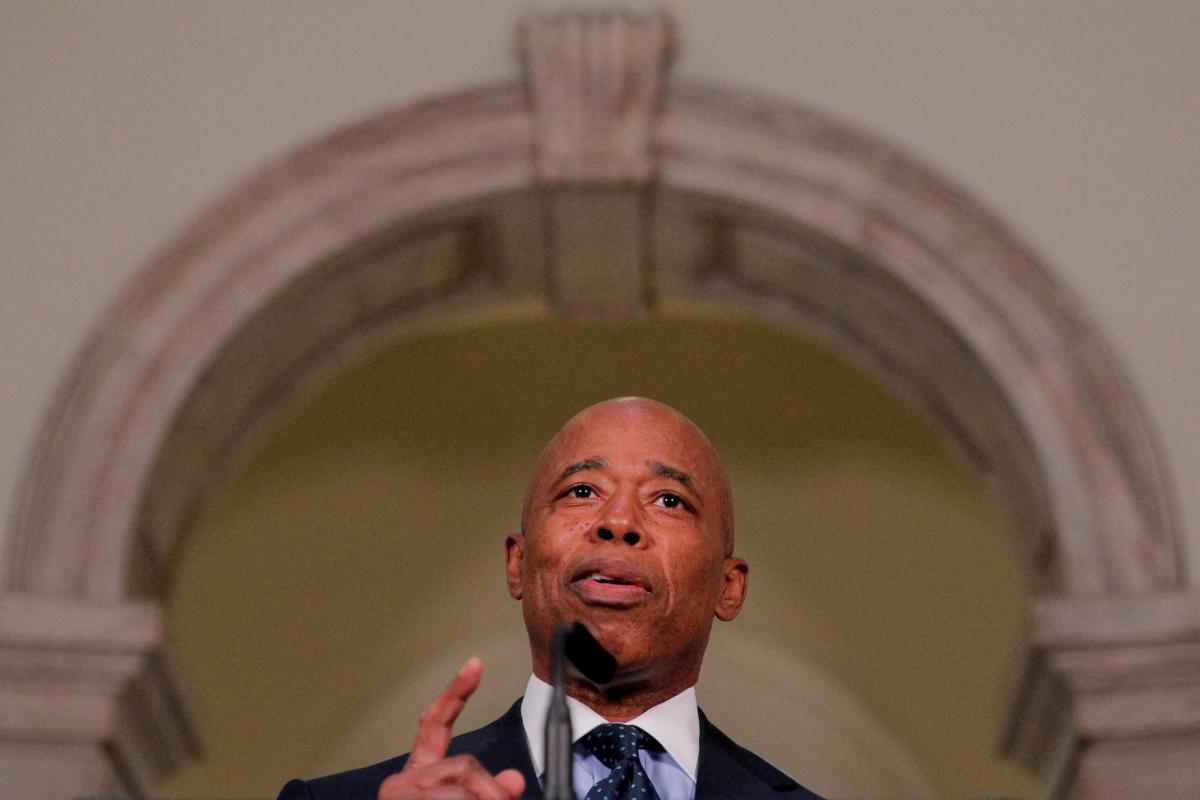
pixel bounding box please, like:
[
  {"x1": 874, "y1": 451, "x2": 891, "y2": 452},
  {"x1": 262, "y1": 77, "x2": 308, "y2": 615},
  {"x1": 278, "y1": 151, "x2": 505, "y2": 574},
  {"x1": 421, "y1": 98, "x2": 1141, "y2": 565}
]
[{"x1": 154, "y1": 318, "x2": 1036, "y2": 798}]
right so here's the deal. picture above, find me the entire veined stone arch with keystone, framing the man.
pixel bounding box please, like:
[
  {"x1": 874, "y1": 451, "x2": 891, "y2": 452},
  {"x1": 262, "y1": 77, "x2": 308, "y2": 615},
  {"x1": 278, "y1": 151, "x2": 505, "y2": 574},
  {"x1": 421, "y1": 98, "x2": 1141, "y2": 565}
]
[{"x1": 0, "y1": 14, "x2": 1200, "y2": 798}]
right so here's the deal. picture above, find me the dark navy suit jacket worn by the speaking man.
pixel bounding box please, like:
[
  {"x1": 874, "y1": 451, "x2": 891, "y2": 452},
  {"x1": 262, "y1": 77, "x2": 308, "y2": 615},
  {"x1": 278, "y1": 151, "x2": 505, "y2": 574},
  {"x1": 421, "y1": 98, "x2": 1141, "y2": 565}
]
[{"x1": 278, "y1": 700, "x2": 821, "y2": 800}]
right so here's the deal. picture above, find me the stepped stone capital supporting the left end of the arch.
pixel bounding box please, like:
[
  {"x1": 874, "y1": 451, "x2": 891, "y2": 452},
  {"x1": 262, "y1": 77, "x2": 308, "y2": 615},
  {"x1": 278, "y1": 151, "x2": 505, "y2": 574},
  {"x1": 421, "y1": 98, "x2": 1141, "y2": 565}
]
[{"x1": 0, "y1": 594, "x2": 200, "y2": 798}]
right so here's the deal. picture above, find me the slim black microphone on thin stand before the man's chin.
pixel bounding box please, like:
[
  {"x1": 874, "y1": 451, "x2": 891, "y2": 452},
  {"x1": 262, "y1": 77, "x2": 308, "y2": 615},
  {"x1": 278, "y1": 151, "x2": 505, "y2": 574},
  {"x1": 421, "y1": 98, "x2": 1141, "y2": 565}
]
[{"x1": 542, "y1": 622, "x2": 617, "y2": 800}]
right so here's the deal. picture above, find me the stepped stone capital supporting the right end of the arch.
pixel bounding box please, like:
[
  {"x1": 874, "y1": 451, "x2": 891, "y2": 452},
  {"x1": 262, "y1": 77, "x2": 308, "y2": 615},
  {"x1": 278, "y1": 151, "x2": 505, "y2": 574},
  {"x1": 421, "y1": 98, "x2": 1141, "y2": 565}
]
[{"x1": 1003, "y1": 591, "x2": 1200, "y2": 800}]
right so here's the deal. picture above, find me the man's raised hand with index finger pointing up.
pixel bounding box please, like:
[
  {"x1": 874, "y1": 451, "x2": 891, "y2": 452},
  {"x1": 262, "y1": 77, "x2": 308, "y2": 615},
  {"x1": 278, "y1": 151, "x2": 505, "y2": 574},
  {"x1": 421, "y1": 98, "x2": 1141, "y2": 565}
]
[{"x1": 379, "y1": 658, "x2": 524, "y2": 800}]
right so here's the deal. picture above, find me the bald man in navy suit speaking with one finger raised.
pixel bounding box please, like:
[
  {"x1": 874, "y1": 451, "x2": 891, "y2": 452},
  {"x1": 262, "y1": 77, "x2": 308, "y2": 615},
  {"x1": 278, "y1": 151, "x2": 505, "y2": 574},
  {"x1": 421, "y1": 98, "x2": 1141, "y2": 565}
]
[{"x1": 280, "y1": 397, "x2": 820, "y2": 800}]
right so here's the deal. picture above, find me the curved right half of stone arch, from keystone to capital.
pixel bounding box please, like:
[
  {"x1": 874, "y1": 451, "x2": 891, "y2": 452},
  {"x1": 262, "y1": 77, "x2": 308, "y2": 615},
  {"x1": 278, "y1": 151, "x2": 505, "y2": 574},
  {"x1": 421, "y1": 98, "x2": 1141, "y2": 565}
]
[{"x1": 656, "y1": 84, "x2": 1184, "y2": 595}]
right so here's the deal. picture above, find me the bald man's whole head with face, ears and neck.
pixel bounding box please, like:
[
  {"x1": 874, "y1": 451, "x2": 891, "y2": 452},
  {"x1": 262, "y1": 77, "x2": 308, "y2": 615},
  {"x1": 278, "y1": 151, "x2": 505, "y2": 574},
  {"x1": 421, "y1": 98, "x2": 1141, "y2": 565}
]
[{"x1": 508, "y1": 398, "x2": 746, "y2": 686}]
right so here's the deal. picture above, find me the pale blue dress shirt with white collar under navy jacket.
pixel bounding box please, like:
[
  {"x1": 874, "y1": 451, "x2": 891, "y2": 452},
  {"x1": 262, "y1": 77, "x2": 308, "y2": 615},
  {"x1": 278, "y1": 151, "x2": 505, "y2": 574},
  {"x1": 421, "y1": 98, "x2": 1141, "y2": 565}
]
[{"x1": 521, "y1": 675, "x2": 700, "y2": 800}]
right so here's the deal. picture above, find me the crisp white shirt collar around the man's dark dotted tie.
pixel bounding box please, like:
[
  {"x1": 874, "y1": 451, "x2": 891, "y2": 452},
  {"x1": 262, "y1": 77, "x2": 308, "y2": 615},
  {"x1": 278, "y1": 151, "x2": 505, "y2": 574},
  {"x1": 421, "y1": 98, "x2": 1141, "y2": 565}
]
[{"x1": 521, "y1": 675, "x2": 700, "y2": 781}]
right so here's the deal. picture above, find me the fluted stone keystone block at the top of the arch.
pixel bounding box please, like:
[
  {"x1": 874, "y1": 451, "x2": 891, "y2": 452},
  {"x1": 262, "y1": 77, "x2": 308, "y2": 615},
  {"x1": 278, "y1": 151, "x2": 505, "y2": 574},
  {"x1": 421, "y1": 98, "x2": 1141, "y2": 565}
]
[{"x1": 517, "y1": 13, "x2": 673, "y2": 320}]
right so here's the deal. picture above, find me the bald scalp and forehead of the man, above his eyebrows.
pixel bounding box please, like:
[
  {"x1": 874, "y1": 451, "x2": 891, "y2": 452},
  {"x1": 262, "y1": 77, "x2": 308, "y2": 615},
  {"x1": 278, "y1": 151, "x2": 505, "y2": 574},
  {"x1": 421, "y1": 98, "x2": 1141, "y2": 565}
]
[{"x1": 521, "y1": 397, "x2": 733, "y2": 555}]
